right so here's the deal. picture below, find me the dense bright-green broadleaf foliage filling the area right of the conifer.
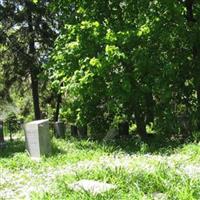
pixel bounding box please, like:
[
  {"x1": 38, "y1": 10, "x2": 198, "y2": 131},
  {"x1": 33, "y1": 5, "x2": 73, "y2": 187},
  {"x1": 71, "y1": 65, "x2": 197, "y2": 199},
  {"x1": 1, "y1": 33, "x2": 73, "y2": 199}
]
[{"x1": 47, "y1": 0, "x2": 200, "y2": 139}]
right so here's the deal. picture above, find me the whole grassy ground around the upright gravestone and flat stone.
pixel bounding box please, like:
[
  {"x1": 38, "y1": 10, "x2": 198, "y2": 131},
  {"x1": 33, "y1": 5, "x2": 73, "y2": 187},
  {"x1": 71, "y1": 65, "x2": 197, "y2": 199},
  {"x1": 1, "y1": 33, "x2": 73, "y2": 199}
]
[{"x1": 0, "y1": 134, "x2": 200, "y2": 200}]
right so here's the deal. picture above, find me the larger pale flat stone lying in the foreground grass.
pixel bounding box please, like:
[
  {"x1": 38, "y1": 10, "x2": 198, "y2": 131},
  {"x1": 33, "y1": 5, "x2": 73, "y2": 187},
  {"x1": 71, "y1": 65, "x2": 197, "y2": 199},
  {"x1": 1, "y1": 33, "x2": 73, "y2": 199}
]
[{"x1": 69, "y1": 180, "x2": 117, "y2": 195}]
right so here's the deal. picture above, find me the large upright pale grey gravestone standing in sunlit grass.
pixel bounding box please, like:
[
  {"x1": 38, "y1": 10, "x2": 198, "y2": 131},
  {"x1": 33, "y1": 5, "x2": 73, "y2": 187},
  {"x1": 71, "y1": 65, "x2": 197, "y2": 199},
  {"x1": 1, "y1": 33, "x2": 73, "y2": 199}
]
[{"x1": 24, "y1": 120, "x2": 51, "y2": 158}]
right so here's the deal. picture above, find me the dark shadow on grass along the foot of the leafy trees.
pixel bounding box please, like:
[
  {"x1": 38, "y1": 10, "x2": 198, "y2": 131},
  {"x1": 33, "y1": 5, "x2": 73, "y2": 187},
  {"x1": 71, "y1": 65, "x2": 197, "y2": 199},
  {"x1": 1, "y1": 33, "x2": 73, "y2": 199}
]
[{"x1": 71, "y1": 135, "x2": 190, "y2": 155}]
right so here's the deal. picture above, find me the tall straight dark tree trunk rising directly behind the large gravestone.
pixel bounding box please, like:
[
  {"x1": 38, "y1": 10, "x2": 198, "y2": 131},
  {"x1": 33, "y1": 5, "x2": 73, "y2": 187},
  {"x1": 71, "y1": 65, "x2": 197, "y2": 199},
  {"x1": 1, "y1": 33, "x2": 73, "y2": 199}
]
[{"x1": 26, "y1": 1, "x2": 41, "y2": 120}]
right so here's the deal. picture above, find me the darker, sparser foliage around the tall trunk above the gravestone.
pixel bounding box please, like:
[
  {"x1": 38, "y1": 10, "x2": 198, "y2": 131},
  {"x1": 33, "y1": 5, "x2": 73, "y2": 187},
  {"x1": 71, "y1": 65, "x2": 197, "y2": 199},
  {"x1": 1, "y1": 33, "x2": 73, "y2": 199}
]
[{"x1": 0, "y1": 0, "x2": 58, "y2": 119}]
